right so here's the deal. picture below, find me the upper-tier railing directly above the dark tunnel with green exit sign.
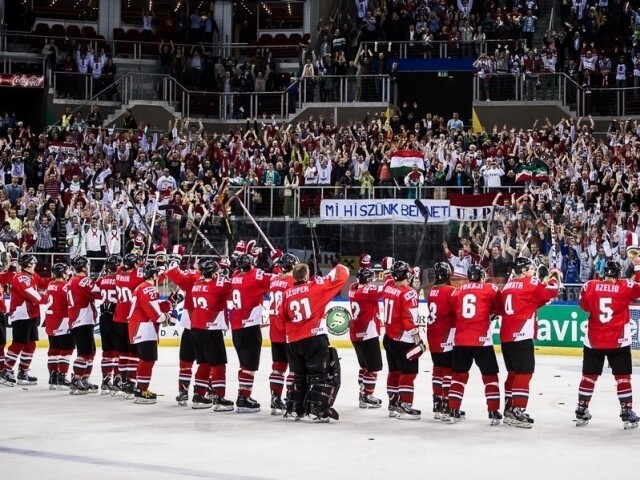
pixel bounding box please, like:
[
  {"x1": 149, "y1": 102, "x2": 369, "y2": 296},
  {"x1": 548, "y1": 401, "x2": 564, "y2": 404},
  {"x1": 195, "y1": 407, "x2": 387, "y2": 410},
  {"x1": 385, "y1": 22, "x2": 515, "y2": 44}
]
[{"x1": 361, "y1": 39, "x2": 524, "y2": 59}]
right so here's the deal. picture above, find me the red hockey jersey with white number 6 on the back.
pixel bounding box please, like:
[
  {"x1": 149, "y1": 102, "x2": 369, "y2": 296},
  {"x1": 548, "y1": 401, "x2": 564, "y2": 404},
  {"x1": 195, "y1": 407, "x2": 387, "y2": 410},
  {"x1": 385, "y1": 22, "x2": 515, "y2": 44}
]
[{"x1": 453, "y1": 282, "x2": 502, "y2": 347}]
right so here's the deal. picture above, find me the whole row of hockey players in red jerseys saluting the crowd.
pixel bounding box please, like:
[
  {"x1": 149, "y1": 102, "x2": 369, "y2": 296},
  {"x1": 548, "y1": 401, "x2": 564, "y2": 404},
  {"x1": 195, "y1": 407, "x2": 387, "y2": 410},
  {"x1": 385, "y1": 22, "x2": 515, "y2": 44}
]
[{"x1": 0, "y1": 241, "x2": 640, "y2": 429}]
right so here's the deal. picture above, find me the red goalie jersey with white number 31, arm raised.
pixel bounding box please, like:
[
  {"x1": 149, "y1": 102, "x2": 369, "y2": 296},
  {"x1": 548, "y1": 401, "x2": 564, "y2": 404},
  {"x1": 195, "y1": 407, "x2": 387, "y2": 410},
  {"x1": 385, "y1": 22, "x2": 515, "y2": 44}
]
[{"x1": 282, "y1": 265, "x2": 349, "y2": 343}]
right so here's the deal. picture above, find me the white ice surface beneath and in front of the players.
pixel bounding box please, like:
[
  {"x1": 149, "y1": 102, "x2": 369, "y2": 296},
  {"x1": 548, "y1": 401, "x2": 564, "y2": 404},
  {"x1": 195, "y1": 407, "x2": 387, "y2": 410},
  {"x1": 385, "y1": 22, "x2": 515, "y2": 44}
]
[{"x1": 0, "y1": 347, "x2": 640, "y2": 480}]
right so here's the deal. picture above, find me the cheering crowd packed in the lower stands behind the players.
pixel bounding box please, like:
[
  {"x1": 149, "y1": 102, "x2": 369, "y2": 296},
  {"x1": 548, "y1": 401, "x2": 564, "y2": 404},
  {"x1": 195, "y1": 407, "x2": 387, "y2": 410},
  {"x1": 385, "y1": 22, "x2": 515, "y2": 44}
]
[{"x1": 0, "y1": 96, "x2": 640, "y2": 281}]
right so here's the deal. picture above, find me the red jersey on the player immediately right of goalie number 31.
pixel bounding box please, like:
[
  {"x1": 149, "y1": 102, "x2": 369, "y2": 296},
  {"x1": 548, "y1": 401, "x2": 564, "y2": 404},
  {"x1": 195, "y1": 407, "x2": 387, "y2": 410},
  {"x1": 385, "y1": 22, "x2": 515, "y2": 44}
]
[{"x1": 349, "y1": 283, "x2": 382, "y2": 342}]
